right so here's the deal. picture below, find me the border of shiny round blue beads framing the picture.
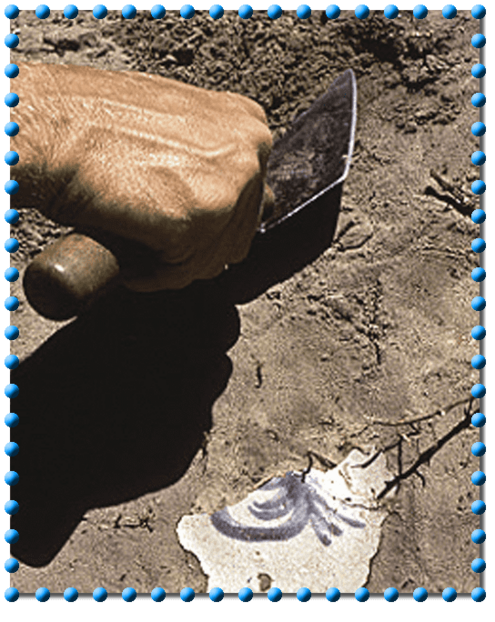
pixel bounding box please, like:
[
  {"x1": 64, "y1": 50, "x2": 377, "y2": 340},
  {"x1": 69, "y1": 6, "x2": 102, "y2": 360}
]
[{"x1": 4, "y1": 3, "x2": 487, "y2": 604}]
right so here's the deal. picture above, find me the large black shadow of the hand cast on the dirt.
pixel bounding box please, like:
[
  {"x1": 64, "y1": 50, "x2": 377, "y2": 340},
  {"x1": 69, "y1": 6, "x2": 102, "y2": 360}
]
[{"x1": 10, "y1": 282, "x2": 239, "y2": 566}]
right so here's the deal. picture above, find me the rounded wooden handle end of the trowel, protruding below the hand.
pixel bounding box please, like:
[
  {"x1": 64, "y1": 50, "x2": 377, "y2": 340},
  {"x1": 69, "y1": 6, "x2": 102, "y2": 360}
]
[{"x1": 23, "y1": 233, "x2": 120, "y2": 320}]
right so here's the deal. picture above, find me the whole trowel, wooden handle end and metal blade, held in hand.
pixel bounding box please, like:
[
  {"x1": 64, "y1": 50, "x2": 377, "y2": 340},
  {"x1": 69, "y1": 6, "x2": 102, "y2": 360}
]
[{"x1": 23, "y1": 69, "x2": 357, "y2": 320}]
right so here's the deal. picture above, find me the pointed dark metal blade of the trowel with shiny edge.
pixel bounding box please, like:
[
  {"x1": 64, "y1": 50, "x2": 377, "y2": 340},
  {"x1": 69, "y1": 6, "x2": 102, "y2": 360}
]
[{"x1": 258, "y1": 69, "x2": 357, "y2": 234}]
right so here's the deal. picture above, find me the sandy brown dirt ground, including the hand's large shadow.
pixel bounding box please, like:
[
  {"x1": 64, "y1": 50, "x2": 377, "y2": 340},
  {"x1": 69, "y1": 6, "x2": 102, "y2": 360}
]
[{"x1": 9, "y1": 9, "x2": 482, "y2": 593}]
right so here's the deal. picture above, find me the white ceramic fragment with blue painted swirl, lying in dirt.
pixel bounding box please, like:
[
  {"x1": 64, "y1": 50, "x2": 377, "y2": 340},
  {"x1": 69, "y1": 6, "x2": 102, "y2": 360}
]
[{"x1": 177, "y1": 450, "x2": 393, "y2": 593}]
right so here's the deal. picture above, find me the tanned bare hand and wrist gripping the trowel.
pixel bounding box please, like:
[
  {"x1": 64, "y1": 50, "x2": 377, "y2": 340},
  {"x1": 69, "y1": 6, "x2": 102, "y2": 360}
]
[{"x1": 9, "y1": 62, "x2": 273, "y2": 292}]
